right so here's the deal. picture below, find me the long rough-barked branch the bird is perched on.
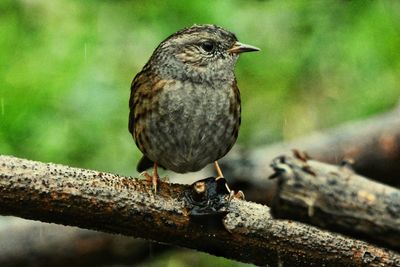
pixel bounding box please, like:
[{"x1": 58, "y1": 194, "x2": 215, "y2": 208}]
[{"x1": 0, "y1": 156, "x2": 400, "y2": 266}]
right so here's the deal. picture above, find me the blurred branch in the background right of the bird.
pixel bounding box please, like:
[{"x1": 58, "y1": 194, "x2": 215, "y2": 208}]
[{"x1": 220, "y1": 108, "x2": 400, "y2": 203}]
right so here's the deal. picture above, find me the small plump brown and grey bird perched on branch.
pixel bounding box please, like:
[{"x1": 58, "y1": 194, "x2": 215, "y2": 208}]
[{"x1": 128, "y1": 24, "x2": 260, "y2": 192}]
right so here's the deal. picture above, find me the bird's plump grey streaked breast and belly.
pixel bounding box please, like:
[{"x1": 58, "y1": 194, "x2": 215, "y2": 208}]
[{"x1": 141, "y1": 81, "x2": 240, "y2": 172}]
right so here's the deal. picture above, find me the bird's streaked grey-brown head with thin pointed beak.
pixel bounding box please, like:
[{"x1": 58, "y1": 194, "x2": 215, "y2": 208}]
[{"x1": 152, "y1": 24, "x2": 259, "y2": 82}]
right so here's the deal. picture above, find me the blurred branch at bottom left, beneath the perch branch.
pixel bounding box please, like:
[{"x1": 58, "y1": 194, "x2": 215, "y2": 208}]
[{"x1": 0, "y1": 218, "x2": 167, "y2": 267}]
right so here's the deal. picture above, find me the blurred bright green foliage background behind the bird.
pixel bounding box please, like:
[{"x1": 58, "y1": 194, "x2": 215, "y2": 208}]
[{"x1": 0, "y1": 0, "x2": 400, "y2": 266}]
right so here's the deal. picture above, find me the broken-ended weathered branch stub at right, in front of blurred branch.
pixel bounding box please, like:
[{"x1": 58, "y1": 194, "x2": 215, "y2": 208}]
[{"x1": 272, "y1": 156, "x2": 400, "y2": 251}]
